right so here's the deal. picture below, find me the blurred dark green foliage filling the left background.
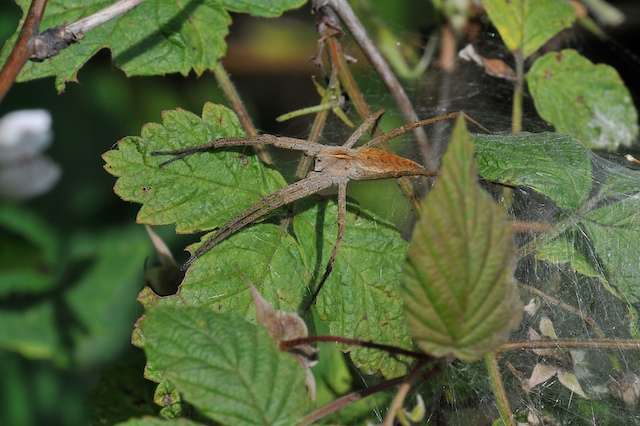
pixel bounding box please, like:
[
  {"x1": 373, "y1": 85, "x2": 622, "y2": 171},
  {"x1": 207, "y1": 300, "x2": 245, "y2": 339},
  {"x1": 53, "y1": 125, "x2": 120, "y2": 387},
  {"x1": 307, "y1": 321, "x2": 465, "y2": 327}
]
[{"x1": 0, "y1": 2, "x2": 238, "y2": 426}]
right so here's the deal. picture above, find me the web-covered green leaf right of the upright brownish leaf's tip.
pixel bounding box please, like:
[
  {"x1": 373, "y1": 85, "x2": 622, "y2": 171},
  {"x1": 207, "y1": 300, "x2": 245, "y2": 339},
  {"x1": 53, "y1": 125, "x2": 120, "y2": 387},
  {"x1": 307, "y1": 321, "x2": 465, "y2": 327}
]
[{"x1": 471, "y1": 132, "x2": 591, "y2": 210}]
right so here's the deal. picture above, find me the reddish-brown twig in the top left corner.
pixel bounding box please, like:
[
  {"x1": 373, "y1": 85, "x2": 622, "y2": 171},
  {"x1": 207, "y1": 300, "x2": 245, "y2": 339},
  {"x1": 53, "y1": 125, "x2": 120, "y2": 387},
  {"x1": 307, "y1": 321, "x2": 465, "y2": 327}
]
[{"x1": 0, "y1": 0, "x2": 47, "y2": 102}]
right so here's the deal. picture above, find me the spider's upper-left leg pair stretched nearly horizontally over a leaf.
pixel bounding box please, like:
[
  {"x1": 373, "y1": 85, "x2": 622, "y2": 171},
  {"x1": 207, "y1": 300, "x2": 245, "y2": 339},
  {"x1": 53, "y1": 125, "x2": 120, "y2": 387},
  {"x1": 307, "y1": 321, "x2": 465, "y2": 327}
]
[{"x1": 151, "y1": 135, "x2": 324, "y2": 167}]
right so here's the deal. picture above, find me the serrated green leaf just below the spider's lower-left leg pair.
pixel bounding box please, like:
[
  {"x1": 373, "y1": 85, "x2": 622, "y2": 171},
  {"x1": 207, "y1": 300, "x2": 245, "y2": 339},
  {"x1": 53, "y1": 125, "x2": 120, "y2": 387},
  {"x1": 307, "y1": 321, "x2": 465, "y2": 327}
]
[{"x1": 176, "y1": 224, "x2": 309, "y2": 320}]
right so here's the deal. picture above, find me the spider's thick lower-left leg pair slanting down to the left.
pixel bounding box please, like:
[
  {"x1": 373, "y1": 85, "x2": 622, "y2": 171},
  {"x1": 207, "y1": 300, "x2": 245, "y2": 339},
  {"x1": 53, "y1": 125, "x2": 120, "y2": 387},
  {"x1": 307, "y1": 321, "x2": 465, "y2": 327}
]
[{"x1": 182, "y1": 174, "x2": 335, "y2": 270}]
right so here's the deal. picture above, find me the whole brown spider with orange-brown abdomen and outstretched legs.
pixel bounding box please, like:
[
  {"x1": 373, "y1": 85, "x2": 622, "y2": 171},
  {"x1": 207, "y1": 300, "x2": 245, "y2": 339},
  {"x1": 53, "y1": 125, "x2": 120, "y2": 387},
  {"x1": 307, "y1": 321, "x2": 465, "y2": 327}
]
[{"x1": 152, "y1": 110, "x2": 486, "y2": 304}]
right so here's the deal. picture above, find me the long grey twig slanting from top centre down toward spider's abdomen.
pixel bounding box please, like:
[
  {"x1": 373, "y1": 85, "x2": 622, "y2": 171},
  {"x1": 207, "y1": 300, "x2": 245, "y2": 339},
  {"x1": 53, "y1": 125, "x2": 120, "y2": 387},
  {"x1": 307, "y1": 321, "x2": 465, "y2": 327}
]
[{"x1": 314, "y1": 0, "x2": 436, "y2": 170}]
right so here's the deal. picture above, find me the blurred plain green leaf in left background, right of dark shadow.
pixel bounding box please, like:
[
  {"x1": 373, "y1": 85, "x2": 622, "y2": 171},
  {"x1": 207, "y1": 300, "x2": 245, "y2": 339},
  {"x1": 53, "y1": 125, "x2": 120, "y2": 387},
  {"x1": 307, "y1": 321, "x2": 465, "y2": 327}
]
[{"x1": 62, "y1": 226, "x2": 152, "y2": 367}]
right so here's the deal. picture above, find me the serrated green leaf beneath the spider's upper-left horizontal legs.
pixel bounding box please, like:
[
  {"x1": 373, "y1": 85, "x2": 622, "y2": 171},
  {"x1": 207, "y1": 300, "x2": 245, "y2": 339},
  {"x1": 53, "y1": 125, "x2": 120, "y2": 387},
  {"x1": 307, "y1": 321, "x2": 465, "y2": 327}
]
[{"x1": 103, "y1": 103, "x2": 285, "y2": 232}]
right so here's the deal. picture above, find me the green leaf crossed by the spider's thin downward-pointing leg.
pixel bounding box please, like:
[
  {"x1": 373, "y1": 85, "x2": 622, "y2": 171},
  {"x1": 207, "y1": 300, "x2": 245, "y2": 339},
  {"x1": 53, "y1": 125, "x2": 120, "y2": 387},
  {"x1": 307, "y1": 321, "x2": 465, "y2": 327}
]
[{"x1": 294, "y1": 200, "x2": 412, "y2": 377}]
